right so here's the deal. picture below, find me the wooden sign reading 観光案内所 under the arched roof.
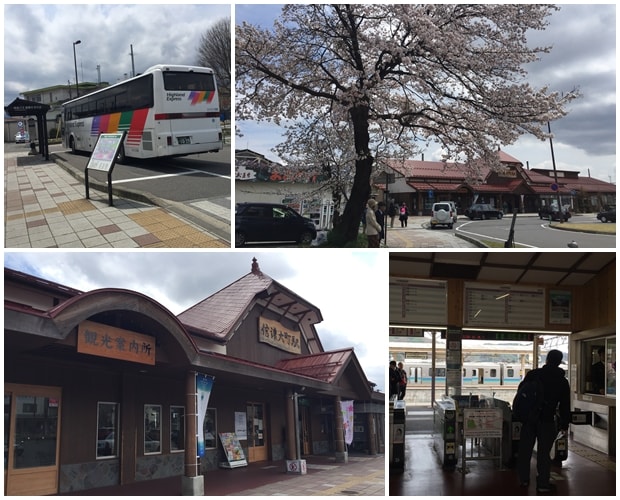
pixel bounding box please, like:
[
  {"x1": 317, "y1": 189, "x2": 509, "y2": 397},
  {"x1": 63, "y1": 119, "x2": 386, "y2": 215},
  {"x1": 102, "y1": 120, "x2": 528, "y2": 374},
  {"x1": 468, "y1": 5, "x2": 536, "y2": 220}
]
[{"x1": 77, "y1": 321, "x2": 155, "y2": 365}]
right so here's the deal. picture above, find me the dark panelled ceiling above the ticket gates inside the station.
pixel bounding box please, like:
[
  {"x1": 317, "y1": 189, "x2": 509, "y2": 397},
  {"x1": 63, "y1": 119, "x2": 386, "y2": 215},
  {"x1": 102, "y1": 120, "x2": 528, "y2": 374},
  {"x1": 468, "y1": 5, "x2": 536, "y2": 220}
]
[{"x1": 389, "y1": 251, "x2": 616, "y2": 286}]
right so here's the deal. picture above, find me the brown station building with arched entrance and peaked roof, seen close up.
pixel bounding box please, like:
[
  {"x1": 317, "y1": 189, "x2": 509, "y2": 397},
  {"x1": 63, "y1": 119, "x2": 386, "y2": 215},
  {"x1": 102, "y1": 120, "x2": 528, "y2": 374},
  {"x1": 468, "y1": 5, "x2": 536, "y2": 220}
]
[{"x1": 4, "y1": 259, "x2": 385, "y2": 495}]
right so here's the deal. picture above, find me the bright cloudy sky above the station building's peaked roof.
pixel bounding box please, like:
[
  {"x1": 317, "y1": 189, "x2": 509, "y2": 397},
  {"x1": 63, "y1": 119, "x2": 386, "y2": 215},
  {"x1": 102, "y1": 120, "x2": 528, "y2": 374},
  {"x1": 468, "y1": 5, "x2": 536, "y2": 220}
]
[{"x1": 4, "y1": 249, "x2": 388, "y2": 390}]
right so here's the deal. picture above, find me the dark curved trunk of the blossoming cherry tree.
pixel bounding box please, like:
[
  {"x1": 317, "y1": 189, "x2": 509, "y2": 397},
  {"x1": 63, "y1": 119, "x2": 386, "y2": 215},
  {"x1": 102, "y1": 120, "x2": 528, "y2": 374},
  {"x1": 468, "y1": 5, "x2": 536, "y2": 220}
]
[{"x1": 332, "y1": 105, "x2": 374, "y2": 246}]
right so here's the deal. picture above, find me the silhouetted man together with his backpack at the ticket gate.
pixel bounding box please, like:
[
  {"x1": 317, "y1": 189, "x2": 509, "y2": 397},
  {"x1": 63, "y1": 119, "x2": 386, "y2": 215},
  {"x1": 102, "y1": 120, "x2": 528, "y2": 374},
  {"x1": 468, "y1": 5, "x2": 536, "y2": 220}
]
[{"x1": 513, "y1": 349, "x2": 570, "y2": 493}]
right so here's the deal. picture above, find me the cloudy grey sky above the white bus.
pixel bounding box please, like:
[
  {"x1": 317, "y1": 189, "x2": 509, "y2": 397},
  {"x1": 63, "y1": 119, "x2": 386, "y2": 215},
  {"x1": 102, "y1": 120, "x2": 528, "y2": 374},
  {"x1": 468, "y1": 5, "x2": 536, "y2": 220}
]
[{"x1": 4, "y1": 4, "x2": 231, "y2": 105}]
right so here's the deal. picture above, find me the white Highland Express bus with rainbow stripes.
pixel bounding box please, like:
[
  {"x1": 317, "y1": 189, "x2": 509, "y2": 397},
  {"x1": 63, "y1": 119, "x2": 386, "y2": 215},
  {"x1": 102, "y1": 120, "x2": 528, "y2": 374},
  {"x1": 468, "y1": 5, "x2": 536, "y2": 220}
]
[{"x1": 63, "y1": 64, "x2": 222, "y2": 161}]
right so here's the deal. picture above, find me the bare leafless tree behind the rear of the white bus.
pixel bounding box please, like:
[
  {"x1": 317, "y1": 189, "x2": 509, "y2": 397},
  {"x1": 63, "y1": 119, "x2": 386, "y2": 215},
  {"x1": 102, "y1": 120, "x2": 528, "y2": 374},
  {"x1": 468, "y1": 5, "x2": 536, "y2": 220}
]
[{"x1": 198, "y1": 17, "x2": 232, "y2": 108}]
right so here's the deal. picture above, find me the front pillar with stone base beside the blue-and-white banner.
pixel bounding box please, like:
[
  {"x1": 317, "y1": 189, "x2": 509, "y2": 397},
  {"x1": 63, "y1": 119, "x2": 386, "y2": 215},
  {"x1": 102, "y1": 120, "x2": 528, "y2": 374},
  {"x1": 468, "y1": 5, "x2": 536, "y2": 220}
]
[{"x1": 181, "y1": 371, "x2": 205, "y2": 496}]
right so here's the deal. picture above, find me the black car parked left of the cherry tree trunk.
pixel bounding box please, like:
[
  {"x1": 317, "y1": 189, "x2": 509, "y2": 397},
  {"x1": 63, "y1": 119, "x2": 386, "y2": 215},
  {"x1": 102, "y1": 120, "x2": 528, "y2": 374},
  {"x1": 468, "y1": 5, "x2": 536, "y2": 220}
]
[{"x1": 235, "y1": 203, "x2": 317, "y2": 247}]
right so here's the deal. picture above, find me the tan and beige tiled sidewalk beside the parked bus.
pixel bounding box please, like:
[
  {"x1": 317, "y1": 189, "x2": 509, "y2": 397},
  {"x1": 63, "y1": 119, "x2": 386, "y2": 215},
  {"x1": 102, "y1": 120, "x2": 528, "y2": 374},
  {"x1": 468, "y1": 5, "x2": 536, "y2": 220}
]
[{"x1": 4, "y1": 151, "x2": 230, "y2": 248}]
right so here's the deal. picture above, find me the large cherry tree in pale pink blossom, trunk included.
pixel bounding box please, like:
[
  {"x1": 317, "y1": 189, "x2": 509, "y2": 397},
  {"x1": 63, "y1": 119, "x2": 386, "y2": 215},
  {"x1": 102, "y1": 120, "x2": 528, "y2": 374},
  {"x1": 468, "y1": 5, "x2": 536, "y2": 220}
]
[{"x1": 235, "y1": 4, "x2": 577, "y2": 245}]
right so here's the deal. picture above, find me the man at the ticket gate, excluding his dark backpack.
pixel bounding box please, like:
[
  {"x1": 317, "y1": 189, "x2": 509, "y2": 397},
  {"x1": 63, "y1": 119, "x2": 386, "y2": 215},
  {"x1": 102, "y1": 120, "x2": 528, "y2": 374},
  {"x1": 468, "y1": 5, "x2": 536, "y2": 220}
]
[{"x1": 517, "y1": 349, "x2": 570, "y2": 493}]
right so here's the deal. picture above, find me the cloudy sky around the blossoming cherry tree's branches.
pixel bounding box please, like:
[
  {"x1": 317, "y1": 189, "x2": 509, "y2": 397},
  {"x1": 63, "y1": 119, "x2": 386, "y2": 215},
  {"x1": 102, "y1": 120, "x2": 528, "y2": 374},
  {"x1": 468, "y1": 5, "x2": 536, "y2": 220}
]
[{"x1": 235, "y1": 4, "x2": 616, "y2": 183}]
